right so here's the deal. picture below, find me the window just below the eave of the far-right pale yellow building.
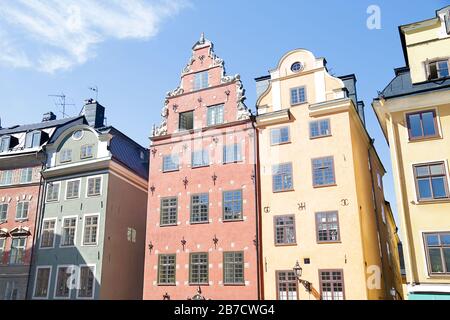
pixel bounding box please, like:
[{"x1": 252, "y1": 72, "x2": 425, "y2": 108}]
[{"x1": 406, "y1": 110, "x2": 438, "y2": 140}]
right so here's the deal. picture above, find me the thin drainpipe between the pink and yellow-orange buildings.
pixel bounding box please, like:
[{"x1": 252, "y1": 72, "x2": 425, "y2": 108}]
[{"x1": 252, "y1": 118, "x2": 264, "y2": 300}]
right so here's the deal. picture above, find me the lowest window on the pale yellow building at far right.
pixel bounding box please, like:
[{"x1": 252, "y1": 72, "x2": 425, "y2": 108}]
[{"x1": 424, "y1": 232, "x2": 450, "y2": 274}]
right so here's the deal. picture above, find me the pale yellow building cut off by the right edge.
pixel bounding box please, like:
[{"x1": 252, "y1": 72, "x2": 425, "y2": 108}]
[{"x1": 372, "y1": 6, "x2": 450, "y2": 299}]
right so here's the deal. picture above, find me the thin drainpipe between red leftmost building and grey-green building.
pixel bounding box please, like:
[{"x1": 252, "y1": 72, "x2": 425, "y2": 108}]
[{"x1": 25, "y1": 147, "x2": 47, "y2": 300}]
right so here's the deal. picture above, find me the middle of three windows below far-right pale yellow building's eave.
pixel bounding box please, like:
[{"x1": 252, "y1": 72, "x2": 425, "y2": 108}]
[{"x1": 414, "y1": 162, "x2": 448, "y2": 201}]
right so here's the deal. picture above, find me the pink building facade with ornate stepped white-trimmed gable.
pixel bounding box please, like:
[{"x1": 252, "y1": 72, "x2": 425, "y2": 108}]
[{"x1": 143, "y1": 35, "x2": 260, "y2": 300}]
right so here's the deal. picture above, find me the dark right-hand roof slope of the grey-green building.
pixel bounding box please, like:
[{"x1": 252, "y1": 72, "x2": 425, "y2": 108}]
[{"x1": 97, "y1": 126, "x2": 149, "y2": 179}]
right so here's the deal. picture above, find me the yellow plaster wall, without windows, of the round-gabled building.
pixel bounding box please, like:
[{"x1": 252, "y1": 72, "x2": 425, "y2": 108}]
[{"x1": 257, "y1": 50, "x2": 398, "y2": 299}]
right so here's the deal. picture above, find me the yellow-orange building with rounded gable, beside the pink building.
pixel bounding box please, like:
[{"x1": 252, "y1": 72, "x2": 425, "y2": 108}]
[{"x1": 256, "y1": 49, "x2": 402, "y2": 300}]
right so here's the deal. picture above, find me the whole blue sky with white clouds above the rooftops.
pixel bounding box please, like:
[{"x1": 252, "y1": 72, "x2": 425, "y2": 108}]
[{"x1": 0, "y1": 0, "x2": 448, "y2": 230}]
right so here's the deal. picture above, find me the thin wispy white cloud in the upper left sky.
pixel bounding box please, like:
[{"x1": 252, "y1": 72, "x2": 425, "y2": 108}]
[{"x1": 0, "y1": 0, "x2": 188, "y2": 73}]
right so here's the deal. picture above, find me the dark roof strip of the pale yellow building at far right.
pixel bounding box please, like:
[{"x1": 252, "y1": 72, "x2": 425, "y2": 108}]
[{"x1": 381, "y1": 67, "x2": 450, "y2": 99}]
